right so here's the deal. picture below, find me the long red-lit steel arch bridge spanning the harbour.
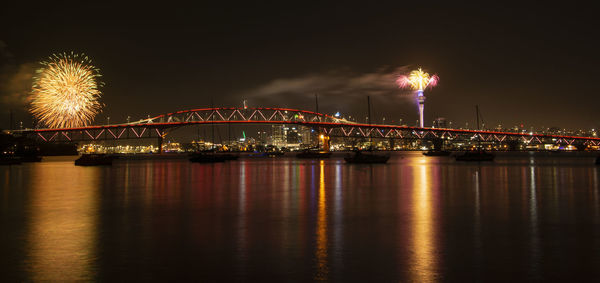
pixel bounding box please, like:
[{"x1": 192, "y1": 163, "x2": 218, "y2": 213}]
[{"x1": 12, "y1": 107, "x2": 600, "y2": 146}]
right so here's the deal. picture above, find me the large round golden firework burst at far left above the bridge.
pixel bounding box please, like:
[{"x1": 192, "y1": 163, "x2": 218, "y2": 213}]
[{"x1": 29, "y1": 53, "x2": 103, "y2": 128}]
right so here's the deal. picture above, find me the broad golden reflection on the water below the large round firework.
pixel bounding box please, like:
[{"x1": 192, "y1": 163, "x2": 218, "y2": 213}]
[{"x1": 26, "y1": 162, "x2": 103, "y2": 281}]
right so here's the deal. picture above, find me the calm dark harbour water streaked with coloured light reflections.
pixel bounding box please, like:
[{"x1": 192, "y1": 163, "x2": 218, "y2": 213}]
[{"x1": 0, "y1": 153, "x2": 600, "y2": 282}]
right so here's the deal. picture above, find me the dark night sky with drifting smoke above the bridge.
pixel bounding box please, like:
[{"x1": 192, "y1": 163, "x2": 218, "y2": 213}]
[{"x1": 0, "y1": 1, "x2": 600, "y2": 129}]
